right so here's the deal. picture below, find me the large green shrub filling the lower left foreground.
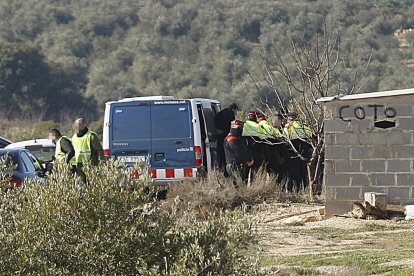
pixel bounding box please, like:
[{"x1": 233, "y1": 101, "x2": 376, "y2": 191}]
[{"x1": 0, "y1": 162, "x2": 256, "y2": 275}]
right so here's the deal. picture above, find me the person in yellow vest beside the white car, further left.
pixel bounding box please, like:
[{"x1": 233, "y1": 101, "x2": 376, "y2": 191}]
[{"x1": 49, "y1": 128, "x2": 75, "y2": 165}]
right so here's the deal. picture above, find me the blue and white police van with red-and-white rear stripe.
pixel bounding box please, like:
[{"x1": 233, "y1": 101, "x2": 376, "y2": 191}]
[{"x1": 103, "y1": 96, "x2": 221, "y2": 184}]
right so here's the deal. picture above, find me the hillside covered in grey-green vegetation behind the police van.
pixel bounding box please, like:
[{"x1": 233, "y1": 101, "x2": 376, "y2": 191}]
[{"x1": 0, "y1": 0, "x2": 414, "y2": 122}]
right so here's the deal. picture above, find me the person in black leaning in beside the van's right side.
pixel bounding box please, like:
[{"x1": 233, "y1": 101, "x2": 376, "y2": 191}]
[{"x1": 215, "y1": 103, "x2": 239, "y2": 170}]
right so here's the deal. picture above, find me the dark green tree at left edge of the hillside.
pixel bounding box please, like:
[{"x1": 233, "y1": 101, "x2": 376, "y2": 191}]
[{"x1": 0, "y1": 43, "x2": 95, "y2": 120}]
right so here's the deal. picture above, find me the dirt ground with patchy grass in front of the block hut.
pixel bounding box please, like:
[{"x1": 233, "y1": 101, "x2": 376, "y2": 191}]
[{"x1": 255, "y1": 203, "x2": 414, "y2": 275}]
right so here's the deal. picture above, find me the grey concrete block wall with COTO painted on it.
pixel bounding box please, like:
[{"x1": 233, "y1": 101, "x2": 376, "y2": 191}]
[{"x1": 324, "y1": 97, "x2": 414, "y2": 217}]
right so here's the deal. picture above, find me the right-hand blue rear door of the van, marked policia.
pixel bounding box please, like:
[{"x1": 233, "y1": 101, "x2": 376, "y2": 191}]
[{"x1": 151, "y1": 100, "x2": 195, "y2": 168}]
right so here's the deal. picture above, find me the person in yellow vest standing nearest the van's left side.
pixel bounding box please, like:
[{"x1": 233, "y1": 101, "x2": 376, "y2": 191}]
[{"x1": 72, "y1": 118, "x2": 104, "y2": 183}]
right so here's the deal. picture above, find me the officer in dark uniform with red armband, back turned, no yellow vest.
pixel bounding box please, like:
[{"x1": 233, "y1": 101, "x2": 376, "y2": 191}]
[{"x1": 224, "y1": 121, "x2": 254, "y2": 181}]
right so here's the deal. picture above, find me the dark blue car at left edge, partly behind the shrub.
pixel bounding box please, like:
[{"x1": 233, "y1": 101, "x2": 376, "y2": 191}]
[{"x1": 0, "y1": 148, "x2": 46, "y2": 187}]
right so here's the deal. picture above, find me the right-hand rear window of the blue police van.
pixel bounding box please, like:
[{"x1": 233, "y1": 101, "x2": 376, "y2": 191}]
[{"x1": 151, "y1": 102, "x2": 191, "y2": 139}]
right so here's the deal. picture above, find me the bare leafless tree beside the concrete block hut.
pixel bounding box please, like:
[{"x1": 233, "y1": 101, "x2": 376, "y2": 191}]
[{"x1": 250, "y1": 22, "x2": 371, "y2": 195}]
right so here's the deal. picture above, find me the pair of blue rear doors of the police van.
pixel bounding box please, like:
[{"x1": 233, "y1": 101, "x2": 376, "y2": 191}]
[{"x1": 109, "y1": 100, "x2": 196, "y2": 169}]
